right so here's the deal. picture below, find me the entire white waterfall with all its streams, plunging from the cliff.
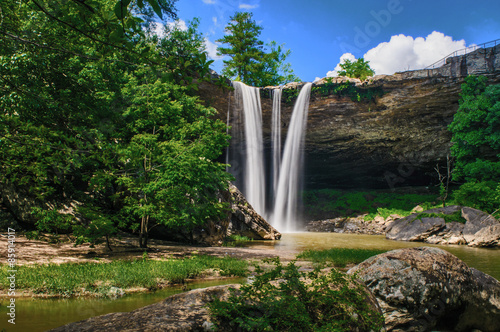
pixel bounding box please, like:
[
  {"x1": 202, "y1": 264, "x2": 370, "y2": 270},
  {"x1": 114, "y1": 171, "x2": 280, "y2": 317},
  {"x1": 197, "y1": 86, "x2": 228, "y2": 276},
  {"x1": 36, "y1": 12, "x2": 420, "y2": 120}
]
[{"x1": 226, "y1": 82, "x2": 312, "y2": 232}]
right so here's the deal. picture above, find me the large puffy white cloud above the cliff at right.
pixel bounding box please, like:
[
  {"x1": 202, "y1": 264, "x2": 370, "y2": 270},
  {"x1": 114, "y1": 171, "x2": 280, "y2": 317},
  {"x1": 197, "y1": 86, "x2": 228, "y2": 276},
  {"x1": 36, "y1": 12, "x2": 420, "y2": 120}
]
[{"x1": 364, "y1": 31, "x2": 466, "y2": 75}]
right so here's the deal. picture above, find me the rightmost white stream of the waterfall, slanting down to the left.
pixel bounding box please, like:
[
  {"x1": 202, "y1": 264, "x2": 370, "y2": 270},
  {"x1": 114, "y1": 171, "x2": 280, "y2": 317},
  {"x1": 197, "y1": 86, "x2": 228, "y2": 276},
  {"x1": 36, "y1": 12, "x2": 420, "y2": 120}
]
[{"x1": 271, "y1": 83, "x2": 312, "y2": 232}]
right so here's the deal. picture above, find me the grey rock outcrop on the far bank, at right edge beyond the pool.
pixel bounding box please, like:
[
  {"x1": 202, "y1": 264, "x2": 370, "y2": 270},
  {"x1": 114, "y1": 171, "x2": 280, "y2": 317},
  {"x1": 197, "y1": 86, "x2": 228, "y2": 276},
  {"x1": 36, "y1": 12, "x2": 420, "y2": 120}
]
[{"x1": 386, "y1": 205, "x2": 500, "y2": 247}]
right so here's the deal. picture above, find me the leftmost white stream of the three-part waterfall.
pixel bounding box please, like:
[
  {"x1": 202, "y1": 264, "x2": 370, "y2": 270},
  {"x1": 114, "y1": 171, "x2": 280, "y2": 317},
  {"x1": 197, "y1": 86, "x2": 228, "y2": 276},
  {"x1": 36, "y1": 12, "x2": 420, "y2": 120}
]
[{"x1": 233, "y1": 82, "x2": 266, "y2": 216}]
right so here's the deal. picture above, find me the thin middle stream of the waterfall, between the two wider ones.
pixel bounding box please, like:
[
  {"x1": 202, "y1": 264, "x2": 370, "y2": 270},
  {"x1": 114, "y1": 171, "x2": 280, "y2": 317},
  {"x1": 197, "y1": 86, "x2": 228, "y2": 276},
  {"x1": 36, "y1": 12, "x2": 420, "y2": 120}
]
[{"x1": 271, "y1": 89, "x2": 282, "y2": 199}]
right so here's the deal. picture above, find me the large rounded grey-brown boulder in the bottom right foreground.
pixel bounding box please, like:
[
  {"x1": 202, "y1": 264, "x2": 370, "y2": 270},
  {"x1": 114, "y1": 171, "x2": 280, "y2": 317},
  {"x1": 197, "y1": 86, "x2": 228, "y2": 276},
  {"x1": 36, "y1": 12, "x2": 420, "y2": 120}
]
[{"x1": 348, "y1": 247, "x2": 500, "y2": 332}]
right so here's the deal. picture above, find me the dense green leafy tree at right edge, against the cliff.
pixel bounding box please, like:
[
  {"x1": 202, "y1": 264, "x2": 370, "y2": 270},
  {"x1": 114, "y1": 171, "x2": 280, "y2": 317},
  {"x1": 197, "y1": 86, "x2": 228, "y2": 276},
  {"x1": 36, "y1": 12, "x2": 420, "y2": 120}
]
[{"x1": 448, "y1": 76, "x2": 500, "y2": 212}]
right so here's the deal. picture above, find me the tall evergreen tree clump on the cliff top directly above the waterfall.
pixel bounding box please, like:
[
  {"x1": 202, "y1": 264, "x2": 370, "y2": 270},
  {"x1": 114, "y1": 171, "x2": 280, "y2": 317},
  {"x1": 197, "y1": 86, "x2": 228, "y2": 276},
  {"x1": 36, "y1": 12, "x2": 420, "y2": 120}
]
[{"x1": 217, "y1": 12, "x2": 300, "y2": 86}]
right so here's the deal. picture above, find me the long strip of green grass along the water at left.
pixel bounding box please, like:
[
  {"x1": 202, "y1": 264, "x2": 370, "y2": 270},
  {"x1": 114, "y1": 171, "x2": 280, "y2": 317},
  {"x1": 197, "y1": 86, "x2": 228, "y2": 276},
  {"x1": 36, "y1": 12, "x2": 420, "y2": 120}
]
[{"x1": 0, "y1": 256, "x2": 248, "y2": 296}]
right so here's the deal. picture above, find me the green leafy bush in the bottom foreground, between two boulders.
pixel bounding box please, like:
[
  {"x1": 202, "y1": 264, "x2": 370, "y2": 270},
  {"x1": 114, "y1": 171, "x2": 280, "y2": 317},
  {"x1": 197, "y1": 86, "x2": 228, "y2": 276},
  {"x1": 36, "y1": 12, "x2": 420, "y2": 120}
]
[{"x1": 208, "y1": 258, "x2": 383, "y2": 331}]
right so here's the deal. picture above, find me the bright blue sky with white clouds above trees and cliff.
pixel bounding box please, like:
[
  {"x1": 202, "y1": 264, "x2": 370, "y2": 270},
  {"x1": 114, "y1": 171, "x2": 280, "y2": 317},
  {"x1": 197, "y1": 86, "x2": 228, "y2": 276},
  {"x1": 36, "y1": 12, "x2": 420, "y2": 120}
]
[{"x1": 172, "y1": 0, "x2": 500, "y2": 81}]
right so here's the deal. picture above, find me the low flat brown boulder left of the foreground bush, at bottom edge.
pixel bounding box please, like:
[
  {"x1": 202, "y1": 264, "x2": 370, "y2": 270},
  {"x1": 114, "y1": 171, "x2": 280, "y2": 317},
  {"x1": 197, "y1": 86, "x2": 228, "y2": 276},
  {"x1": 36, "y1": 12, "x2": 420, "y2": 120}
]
[{"x1": 51, "y1": 284, "x2": 240, "y2": 332}]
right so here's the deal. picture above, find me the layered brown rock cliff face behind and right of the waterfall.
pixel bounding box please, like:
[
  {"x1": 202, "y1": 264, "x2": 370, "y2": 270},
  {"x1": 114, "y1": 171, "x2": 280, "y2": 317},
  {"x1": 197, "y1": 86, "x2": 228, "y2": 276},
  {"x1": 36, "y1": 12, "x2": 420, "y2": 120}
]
[{"x1": 200, "y1": 46, "x2": 500, "y2": 189}]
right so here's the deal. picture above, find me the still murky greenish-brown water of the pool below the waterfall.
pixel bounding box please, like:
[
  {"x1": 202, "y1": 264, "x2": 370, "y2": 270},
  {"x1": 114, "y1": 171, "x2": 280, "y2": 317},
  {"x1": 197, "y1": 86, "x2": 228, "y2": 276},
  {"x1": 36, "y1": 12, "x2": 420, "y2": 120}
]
[{"x1": 0, "y1": 233, "x2": 500, "y2": 332}]
